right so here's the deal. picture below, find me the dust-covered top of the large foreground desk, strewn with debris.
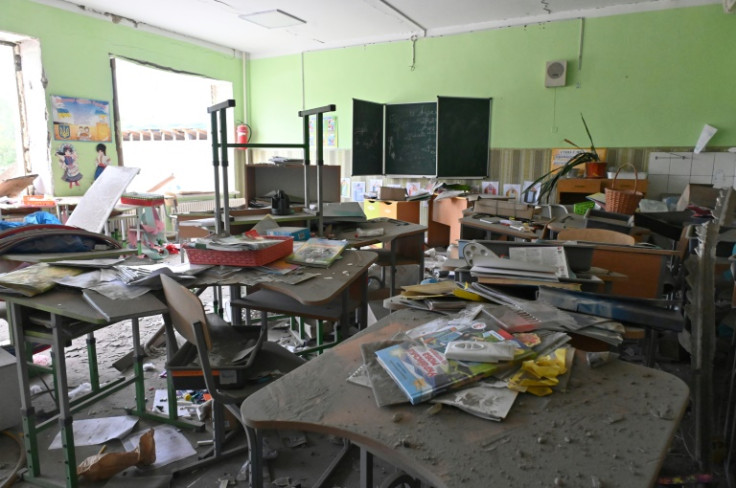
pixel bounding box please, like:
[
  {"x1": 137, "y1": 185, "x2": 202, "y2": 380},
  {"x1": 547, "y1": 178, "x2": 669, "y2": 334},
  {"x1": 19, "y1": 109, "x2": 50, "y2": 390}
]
[{"x1": 241, "y1": 310, "x2": 688, "y2": 488}]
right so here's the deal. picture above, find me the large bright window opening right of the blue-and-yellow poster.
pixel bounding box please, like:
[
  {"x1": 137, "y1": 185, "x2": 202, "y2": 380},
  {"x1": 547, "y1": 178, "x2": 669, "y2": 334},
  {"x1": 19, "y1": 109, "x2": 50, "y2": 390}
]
[{"x1": 113, "y1": 58, "x2": 234, "y2": 192}]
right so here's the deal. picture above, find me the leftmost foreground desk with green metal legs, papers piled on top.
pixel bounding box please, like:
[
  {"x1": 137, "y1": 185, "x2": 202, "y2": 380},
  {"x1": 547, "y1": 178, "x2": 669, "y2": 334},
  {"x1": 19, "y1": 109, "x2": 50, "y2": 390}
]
[{"x1": 0, "y1": 288, "x2": 181, "y2": 487}]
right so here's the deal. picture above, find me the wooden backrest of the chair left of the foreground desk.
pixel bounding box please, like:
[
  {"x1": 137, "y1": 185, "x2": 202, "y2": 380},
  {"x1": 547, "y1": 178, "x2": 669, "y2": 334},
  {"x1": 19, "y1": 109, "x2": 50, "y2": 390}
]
[{"x1": 161, "y1": 274, "x2": 212, "y2": 351}]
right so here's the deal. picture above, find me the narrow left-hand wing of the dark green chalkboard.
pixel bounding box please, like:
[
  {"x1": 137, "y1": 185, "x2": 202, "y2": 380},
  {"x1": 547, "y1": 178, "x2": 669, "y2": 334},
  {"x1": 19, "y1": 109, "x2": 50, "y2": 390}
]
[{"x1": 353, "y1": 98, "x2": 383, "y2": 176}]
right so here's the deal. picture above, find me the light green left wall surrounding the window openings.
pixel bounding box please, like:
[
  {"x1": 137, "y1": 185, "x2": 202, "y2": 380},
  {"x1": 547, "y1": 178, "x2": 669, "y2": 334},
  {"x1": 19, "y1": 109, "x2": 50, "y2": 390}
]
[{"x1": 0, "y1": 0, "x2": 243, "y2": 196}]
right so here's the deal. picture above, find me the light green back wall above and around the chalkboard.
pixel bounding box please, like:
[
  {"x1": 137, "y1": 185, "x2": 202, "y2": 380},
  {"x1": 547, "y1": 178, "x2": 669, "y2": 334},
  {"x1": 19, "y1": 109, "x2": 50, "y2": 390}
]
[{"x1": 248, "y1": 5, "x2": 736, "y2": 148}]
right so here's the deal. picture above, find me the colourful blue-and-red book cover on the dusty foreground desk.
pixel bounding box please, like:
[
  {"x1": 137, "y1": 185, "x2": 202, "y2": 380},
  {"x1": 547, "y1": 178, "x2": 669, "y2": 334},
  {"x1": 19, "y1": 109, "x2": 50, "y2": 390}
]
[{"x1": 376, "y1": 322, "x2": 534, "y2": 404}]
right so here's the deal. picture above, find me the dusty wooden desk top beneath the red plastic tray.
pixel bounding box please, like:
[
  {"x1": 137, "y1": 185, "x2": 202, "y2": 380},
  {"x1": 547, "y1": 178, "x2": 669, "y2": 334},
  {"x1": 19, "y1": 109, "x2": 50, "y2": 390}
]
[{"x1": 189, "y1": 249, "x2": 378, "y2": 305}]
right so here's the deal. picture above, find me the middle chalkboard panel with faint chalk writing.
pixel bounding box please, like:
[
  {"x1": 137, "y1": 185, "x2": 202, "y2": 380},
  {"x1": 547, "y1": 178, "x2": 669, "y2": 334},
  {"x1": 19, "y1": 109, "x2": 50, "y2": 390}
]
[{"x1": 384, "y1": 102, "x2": 437, "y2": 176}]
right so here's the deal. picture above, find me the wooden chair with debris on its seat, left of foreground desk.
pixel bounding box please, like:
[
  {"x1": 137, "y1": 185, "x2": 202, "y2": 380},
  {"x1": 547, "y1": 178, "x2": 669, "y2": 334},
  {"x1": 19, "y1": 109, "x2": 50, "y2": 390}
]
[{"x1": 161, "y1": 275, "x2": 304, "y2": 473}]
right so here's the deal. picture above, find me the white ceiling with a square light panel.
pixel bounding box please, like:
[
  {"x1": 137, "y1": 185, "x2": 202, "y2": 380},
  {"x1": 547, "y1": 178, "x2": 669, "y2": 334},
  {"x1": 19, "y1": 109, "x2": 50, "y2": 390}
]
[{"x1": 34, "y1": 0, "x2": 728, "y2": 58}]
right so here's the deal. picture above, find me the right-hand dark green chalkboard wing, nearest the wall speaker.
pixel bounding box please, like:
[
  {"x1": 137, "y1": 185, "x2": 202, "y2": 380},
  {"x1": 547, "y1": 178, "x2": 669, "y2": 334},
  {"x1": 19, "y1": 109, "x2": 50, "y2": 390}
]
[{"x1": 437, "y1": 97, "x2": 491, "y2": 178}]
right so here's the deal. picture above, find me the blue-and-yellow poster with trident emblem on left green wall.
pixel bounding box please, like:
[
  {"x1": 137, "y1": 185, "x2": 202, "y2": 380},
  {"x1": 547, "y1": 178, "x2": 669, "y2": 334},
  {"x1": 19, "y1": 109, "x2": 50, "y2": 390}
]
[{"x1": 51, "y1": 95, "x2": 111, "y2": 142}]
